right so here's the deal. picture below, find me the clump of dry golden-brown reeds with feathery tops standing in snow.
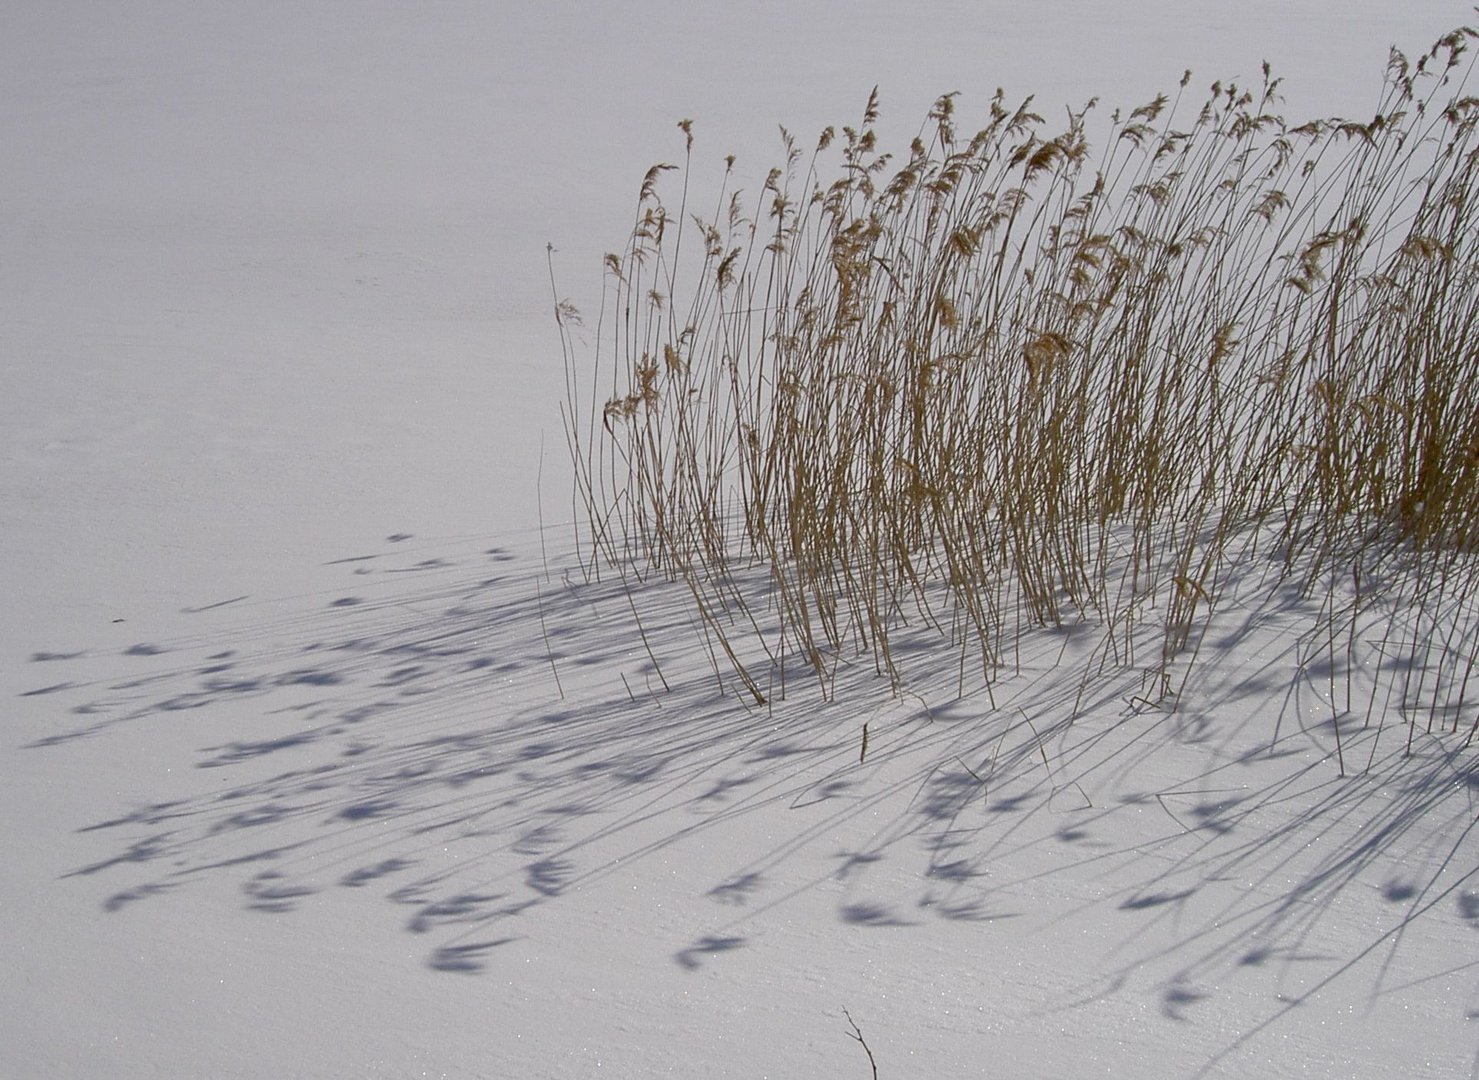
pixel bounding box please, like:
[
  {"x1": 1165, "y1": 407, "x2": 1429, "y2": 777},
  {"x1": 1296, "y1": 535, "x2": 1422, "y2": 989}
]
[{"x1": 556, "y1": 18, "x2": 1479, "y2": 757}]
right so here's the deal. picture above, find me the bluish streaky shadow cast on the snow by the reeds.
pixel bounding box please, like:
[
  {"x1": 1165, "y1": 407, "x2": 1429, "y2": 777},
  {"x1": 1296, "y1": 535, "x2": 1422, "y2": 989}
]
[{"x1": 27, "y1": 523, "x2": 1479, "y2": 1071}]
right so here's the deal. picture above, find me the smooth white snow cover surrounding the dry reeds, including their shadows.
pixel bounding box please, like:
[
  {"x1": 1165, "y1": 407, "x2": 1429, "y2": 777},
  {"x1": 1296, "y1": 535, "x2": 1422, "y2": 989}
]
[{"x1": 0, "y1": 0, "x2": 1479, "y2": 1079}]
